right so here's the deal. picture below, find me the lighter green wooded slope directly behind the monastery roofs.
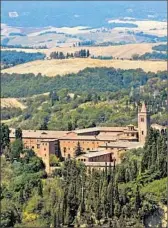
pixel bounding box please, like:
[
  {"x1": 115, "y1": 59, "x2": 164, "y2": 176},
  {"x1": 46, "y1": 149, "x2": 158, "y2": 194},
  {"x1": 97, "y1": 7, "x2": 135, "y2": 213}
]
[{"x1": 3, "y1": 73, "x2": 167, "y2": 130}]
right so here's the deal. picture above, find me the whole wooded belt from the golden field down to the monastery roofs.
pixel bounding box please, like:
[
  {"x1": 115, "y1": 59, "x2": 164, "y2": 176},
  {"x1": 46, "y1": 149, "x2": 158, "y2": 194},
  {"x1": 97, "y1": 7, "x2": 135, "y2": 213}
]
[{"x1": 1, "y1": 68, "x2": 167, "y2": 130}]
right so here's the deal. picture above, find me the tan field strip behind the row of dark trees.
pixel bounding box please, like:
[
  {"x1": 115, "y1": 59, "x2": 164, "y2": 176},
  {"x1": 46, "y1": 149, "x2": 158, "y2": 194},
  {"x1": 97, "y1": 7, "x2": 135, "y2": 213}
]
[{"x1": 2, "y1": 43, "x2": 163, "y2": 59}]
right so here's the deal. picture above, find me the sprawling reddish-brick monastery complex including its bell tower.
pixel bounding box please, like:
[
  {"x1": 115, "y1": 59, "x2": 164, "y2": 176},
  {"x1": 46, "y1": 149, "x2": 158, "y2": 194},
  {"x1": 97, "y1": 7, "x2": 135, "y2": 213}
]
[{"x1": 10, "y1": 104, "x2": 159, "y2": 172}]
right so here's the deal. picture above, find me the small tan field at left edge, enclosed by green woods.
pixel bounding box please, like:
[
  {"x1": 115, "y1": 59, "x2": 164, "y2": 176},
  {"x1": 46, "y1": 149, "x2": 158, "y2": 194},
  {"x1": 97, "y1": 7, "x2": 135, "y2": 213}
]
[{"x1": 1, "y1": 98, "x2": 26, "y2": 110}]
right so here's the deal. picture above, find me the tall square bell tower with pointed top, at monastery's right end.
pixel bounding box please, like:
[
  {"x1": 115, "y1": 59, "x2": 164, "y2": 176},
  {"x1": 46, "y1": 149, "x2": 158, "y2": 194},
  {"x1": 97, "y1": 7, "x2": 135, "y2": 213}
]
[{"x1": 138, "y1": 102, "x2": 150, "y2": 143}]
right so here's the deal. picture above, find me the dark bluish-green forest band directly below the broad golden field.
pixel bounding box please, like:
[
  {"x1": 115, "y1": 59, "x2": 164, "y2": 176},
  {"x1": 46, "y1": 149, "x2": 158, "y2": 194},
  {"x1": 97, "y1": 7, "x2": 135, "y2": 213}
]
[{"x1": 1, "y1": 68, "x2": 166, "y2": 97}]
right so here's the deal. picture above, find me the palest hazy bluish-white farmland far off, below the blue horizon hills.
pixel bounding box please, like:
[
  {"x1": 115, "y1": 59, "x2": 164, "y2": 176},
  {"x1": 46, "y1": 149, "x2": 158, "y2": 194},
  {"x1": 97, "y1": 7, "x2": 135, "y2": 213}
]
[{"x1": 1, "y1": 19, "x2": 167, "y2": 48}]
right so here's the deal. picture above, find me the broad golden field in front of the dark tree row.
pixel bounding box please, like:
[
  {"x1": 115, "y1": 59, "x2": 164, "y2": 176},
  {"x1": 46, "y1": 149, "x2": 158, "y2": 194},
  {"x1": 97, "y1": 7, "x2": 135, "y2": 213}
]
[{"x1": 2, "y1": 58, "x2": 167, "y2": 77}]
